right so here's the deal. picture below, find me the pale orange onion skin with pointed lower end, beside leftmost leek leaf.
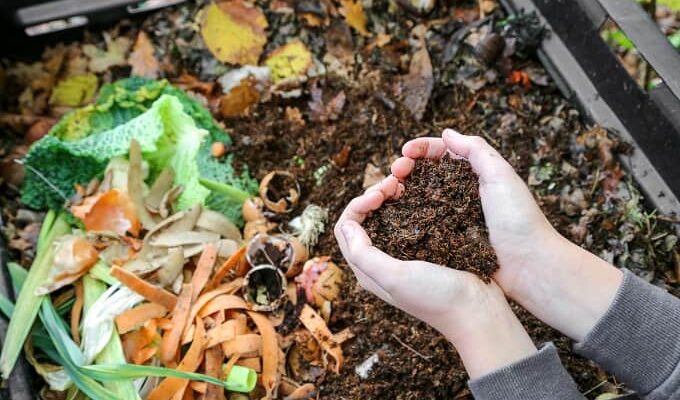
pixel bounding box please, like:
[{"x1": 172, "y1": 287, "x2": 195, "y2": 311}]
[{"x1": 35, "y1": 235, "x2": 99, "y2": 296}]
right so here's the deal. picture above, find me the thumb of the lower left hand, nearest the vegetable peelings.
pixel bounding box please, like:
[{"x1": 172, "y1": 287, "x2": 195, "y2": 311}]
[{"x1": 340, "y1": 221, "x2": 406, "y2": 294}]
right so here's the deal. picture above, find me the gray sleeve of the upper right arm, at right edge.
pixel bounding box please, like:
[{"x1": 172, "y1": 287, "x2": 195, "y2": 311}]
[{"x1": 576, "y1": 270, "x2": 680, "y2": 400}]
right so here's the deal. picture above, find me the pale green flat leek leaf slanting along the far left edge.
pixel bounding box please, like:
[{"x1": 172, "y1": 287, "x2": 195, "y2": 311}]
[{"x1": 0, "y1": 211, "x2": 71, "y2": 379}]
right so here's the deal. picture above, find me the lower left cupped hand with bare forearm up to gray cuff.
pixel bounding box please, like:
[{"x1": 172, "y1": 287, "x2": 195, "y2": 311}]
[{"x1": 335, "y1": 176, "x2": 536, "y2": 378}]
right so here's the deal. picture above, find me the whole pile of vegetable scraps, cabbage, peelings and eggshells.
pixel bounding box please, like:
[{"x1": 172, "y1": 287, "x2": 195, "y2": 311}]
[{"x1": 0, "y1": 78, "x2": 351, "y2": 400}]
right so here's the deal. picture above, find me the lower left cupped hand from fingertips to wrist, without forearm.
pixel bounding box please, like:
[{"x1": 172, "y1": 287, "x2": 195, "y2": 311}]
[{"x1": 335, "y1": 176, "x2": 520, "y2": 342}]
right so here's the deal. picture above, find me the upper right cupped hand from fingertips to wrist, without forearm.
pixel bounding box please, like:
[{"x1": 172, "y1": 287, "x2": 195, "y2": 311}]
[{"x1": 392, "y1": 129, "x2": 562, "y2": 297}]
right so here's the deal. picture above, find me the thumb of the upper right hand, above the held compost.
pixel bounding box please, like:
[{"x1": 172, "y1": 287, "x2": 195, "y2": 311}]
[{"x1": 442, "y1": 129, "x2": 514, "y2": 182}]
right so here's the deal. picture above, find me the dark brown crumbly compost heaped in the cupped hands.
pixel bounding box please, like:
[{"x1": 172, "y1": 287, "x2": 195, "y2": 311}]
[{"x1": 364, "y1": 155, "x2": 498, "y2": 282}]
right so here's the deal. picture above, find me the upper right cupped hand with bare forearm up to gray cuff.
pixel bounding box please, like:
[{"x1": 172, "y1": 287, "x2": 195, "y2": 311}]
[{"x1": 392, "y1": 129, "x2": 622, "y2": 340}]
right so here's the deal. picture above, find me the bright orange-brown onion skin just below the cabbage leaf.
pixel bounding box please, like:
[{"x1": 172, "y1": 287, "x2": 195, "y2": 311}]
[{"x1": 71, "y1": 189, "x2": 141, "y2": 236}]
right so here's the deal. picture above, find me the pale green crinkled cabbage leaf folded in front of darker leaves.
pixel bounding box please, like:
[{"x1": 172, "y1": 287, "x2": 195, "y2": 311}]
[{"x1": 23, "y1": 95, "x2": 209, "y2": 208}]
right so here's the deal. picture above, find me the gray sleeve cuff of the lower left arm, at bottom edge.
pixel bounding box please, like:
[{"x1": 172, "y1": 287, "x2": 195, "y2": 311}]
[{"x1": 469, "y1": 343, "x2": 585, "y2": 400}]
